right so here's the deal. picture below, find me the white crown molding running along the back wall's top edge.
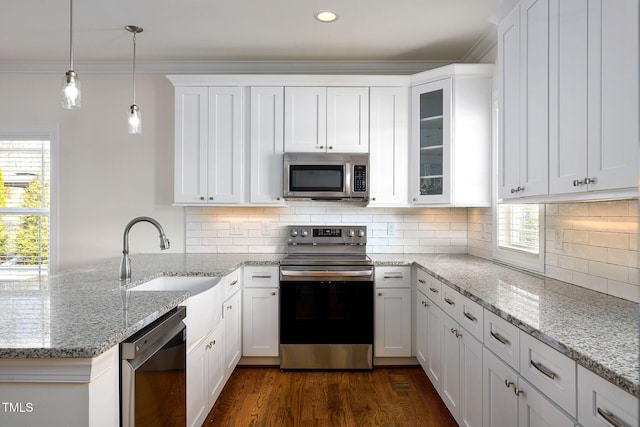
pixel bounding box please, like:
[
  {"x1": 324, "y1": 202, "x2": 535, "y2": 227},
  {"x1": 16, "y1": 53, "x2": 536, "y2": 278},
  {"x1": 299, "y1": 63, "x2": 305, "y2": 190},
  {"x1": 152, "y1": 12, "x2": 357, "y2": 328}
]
[{"x1": 0, "y1": 60, "x2": 456, "y2": 75}]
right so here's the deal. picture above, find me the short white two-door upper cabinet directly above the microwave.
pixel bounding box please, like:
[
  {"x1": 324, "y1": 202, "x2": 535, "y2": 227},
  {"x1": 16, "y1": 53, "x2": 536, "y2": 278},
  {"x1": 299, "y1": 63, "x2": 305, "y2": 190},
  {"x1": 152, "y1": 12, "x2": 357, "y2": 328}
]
[{"x1": 284, "y1": 87, "x2": 369, "y2": 153}]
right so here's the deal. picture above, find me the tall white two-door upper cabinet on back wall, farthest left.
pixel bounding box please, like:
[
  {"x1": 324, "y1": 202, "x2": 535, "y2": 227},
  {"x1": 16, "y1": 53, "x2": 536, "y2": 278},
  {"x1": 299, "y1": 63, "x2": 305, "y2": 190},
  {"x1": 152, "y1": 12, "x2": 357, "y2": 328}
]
[{"x1": 174, "y1": 87, "x2": 242, "y2": 204}]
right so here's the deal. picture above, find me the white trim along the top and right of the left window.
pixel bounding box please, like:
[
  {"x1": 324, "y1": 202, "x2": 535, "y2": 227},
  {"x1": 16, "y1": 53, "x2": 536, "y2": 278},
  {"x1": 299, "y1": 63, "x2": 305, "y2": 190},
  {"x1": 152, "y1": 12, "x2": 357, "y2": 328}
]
[{"x1": 0, "y1": 124, "x2": 59, "y2": 275}]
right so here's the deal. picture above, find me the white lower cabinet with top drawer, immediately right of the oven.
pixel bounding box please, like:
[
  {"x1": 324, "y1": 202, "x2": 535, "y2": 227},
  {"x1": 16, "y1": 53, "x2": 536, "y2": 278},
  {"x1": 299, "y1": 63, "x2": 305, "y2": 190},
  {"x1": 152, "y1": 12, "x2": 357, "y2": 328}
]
[{"x1": 373, "y1": 266, "x2": 411, "y2": 357}]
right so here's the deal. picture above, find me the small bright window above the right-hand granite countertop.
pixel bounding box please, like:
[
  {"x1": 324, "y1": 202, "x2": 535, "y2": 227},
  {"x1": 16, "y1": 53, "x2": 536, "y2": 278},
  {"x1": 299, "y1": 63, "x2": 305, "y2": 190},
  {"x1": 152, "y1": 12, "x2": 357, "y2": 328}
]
[{"x1": 494, "y1": 204, "x2": 544, "y2": 273}]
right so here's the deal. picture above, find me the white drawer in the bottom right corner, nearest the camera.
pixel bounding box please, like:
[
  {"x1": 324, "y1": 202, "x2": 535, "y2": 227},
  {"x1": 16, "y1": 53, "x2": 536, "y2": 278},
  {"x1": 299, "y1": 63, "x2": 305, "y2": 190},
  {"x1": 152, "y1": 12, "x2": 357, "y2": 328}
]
[{"x1": 578, "y1": 366, "x2": 640, "y2": 427}]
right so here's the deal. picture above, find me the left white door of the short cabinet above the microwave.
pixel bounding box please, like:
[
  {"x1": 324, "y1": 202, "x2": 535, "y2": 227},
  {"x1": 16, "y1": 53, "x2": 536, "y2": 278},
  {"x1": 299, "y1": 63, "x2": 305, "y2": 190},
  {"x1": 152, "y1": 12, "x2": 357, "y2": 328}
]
[{"x1": 284, "y1": 87, "x2": 327, "y2": 152}]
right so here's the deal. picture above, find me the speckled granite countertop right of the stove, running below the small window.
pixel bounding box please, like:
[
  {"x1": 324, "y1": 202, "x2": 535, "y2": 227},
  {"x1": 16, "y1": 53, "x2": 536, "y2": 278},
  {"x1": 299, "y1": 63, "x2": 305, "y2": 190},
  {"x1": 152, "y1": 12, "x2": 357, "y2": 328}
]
[{"x1": 370, "y1": 254, "x2": 640, "y2": 397}]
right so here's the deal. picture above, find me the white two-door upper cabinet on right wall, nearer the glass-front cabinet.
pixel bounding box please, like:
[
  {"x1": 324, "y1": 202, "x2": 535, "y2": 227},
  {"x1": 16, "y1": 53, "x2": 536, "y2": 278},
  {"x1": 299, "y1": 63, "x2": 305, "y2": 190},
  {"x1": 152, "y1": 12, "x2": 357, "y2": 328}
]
[{"x1": 498, "y1": 0, "x2": 549, "y2": 199}]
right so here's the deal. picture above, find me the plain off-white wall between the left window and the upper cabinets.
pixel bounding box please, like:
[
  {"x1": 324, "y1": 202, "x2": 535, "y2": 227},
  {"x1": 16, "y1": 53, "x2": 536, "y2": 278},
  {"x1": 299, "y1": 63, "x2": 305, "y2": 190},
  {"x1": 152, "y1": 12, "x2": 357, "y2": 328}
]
[{"x1": 0, "y1": 70, "x2": 184, "y2": 273}]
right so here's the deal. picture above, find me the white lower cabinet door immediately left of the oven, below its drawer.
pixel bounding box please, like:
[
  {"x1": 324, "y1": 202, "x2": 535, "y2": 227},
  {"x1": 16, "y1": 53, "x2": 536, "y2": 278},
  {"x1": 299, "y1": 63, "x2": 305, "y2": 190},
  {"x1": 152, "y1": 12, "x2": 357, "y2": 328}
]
[{"x1": 242, "y1": 288, "x2": 279, "y2": 357}]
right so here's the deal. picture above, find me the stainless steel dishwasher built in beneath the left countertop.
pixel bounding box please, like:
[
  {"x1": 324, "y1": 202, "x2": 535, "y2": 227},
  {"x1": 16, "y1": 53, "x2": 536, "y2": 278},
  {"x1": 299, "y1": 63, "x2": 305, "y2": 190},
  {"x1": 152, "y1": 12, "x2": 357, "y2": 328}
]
[{"x1": 120, "y1": 307, "x2": 187, "y2": 427}]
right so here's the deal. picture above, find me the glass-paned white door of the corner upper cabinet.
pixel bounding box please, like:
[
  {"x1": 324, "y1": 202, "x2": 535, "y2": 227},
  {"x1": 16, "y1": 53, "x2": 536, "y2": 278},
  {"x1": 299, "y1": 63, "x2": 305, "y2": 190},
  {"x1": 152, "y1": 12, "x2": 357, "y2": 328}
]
[{"x1": 411, "y1": 79, "x2": 451, "y2": 204}]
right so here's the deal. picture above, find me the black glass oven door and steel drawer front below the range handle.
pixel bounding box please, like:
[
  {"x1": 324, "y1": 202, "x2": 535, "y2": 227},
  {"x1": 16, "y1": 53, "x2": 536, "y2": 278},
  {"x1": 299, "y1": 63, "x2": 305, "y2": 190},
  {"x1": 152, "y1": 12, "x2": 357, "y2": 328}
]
[{"x1": 280, "y1": 280, "x2": 374, "y2": 369}]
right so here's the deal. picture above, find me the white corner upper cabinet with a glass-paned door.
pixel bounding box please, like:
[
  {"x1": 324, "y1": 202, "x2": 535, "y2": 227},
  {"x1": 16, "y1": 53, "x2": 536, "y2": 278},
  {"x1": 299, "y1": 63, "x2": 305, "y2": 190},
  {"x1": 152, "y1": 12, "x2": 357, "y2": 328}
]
[{"x1": 409, "y1": 64, "x2": 493, "y2": 206}]
